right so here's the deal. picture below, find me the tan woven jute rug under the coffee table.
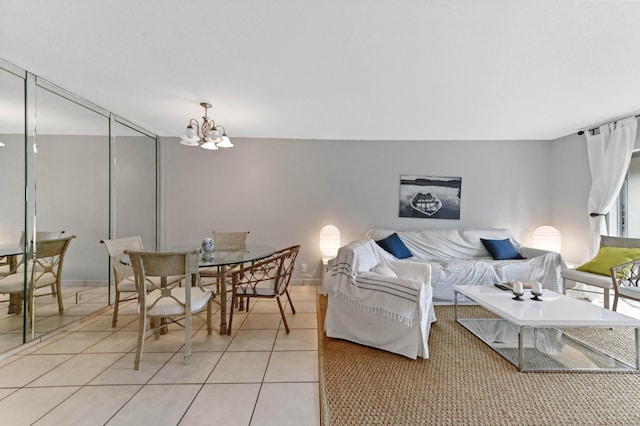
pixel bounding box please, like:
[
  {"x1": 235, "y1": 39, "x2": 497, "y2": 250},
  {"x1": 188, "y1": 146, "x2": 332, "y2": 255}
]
[{"x1": 318, "y1": 296, "x2": 640, "y2": 425}]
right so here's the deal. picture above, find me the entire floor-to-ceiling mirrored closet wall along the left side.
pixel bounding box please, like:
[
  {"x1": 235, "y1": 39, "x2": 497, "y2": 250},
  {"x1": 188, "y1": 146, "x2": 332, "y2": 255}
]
[{"x1": 0, "y1": 59, "x2": 158, "y2": 354}]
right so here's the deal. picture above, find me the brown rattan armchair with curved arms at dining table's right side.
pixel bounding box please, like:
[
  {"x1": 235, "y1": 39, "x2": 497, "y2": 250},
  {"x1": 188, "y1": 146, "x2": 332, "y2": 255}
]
[{"x1": 227, "y1": 245, "x2": 300, "y2": 335}]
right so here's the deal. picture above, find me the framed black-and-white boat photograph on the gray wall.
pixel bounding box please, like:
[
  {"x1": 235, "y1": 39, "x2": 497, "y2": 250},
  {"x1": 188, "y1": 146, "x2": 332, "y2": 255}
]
[{"x1": 400, "y1": 175, "x2": 462, "y2": 219}]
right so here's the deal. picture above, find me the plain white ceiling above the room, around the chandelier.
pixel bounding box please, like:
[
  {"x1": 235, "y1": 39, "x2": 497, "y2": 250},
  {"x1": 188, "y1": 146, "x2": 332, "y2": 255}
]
[{"x1": 0, "y1": 0, "x2": 640, "y2": 140}]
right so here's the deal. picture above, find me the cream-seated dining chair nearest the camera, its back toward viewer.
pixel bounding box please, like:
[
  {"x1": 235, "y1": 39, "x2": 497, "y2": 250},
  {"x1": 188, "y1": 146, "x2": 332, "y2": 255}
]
[{"x1": 125, "y1": 250, "x2": 212, "y2": 370}]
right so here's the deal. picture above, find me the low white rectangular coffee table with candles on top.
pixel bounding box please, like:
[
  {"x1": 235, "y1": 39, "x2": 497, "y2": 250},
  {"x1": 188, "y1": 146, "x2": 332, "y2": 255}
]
[{"x1": 454, "y1": 285, "x2": 640, "y2": 371}]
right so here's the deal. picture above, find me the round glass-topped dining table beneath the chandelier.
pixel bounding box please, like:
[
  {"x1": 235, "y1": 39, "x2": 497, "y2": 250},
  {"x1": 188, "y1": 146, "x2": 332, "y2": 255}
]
[{"x1": 120, "y1": 243, "x2": 276, "y2": 335}]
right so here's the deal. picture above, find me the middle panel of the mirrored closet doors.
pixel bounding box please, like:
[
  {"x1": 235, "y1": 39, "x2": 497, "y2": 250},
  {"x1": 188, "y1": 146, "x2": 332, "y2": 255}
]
[{"x1": 33, "y1": 79, "x2": 109, "y2": 336}]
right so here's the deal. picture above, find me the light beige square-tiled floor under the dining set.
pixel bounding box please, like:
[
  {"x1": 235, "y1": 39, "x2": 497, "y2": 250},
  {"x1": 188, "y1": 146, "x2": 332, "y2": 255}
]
[{"x1": 0, "y1": 285, "x2": 321, "y2": 426}]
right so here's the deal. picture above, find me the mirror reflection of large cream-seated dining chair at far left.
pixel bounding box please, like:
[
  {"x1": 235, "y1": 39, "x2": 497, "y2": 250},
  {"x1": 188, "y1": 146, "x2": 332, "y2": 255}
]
[{"x1": 0, "y1": 235, "x2": 75, "y2": 322}]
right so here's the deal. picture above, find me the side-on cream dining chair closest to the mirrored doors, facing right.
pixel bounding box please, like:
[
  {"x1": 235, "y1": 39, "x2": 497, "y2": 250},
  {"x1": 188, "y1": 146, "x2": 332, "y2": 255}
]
[{"x1": 100, "y1": 235, "x2": 183, "y2": 327}]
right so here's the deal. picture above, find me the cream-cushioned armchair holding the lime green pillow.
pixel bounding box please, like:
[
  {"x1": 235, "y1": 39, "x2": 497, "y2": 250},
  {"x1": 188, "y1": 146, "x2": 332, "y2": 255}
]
[{"x1": 561, "y1": 235, "x2": 640, "y2": 309}]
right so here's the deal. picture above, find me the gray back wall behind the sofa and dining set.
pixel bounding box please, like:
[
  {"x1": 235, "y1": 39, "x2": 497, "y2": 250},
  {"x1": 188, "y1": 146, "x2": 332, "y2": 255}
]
[{"x1": 161, "y1": 136, "x2": 589, "y2": 280}]
